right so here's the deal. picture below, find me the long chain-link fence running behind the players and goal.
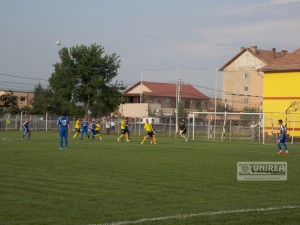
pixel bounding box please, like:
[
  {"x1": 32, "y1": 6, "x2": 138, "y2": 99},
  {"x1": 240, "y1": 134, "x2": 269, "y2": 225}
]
[{"x1": 0, "y1": 112, "x2": 300, "y2": 143}]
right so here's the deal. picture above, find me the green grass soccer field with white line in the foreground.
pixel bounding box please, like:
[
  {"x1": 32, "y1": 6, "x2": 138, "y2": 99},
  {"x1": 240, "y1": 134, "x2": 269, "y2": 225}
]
[{"x1": 0, "y1": 132, "x2": 300, "y2": 225}]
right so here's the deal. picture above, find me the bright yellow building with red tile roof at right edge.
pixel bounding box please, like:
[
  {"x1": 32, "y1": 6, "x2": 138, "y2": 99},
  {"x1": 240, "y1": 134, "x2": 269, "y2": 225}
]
[{"x1": 261, "y1": 48, "x2": 300, "y2": 137}]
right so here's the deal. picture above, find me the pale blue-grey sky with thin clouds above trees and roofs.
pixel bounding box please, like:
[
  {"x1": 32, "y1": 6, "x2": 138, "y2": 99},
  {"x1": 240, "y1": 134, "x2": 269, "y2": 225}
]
[{"x1": 0, "y1": 0, "x2": 300, "y2": 97}]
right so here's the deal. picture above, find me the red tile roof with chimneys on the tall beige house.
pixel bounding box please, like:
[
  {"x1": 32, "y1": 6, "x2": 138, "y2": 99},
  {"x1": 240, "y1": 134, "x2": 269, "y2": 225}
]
[{"x1": 219, "y1": 46, "x2": 286, "y2": 71}]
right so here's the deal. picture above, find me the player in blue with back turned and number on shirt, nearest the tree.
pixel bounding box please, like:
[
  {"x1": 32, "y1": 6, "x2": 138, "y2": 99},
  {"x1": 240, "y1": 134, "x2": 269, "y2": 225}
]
[{"x1": 57, "y1": 112, "x2": 70, "y2": 150}]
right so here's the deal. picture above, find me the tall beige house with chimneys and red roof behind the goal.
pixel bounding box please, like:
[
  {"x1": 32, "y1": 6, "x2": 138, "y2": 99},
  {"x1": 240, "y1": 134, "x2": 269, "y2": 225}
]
[{"x1": 219, "y1": 46, "x2": 287, "y2": 112}]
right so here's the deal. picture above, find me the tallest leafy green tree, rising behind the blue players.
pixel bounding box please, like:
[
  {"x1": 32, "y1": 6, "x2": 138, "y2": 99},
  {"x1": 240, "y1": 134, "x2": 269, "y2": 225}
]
[{"x1": 49, "y1": 44, "x2": 123, "y2": 118}]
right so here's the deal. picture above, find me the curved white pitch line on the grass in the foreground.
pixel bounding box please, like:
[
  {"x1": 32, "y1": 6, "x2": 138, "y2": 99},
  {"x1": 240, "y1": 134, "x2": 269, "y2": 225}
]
[{"x1": 98, "y1": 206, "x2": 300, "y2": 225}]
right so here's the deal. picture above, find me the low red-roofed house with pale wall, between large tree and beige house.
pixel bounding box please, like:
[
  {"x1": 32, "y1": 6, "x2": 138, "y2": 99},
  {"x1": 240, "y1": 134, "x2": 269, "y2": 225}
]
[{"x1": 120, "y1": 81, "x2": 209, "y2": 117}]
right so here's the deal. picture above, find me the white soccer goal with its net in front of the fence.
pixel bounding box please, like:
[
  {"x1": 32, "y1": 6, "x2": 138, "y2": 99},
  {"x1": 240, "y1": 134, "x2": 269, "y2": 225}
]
[{"x1": 192, "y1": 112, "x2": 265, "y2": 144}]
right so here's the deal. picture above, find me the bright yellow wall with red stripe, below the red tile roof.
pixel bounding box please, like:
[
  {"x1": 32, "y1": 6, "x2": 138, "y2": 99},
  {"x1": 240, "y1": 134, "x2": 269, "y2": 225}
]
[{"x1": 263, "y1": 72, "x2": 300, "y2": 137}]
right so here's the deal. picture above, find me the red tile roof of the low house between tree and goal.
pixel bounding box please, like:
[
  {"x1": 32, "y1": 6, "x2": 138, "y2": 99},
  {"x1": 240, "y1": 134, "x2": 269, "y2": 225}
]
[{"x1": 124, "y1": 81, "x2": 209, "y2": 99}]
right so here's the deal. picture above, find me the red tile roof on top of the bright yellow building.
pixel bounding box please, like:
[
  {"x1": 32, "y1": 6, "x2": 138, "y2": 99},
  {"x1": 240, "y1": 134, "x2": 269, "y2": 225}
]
[{"x1": 262, "y1": 48, "x2": 300, "y2": 72}]
